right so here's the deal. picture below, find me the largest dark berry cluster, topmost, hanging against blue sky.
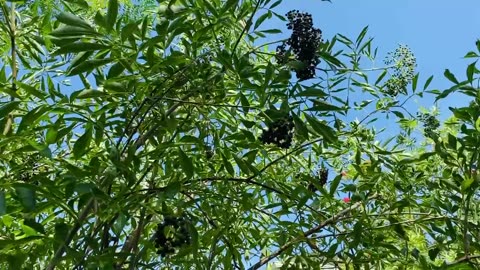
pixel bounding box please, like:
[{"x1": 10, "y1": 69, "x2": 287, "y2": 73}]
[{"x1": 276, "y1": 10, "x2": 322, "y2": 80}]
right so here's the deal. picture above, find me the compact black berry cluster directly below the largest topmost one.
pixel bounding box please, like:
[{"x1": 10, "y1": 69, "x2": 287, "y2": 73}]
[{"x1": 260, "y1": 115, "x2": 295, "y2": 149}]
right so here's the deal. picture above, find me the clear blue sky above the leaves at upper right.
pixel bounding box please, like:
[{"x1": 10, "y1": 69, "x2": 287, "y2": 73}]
[{"x1": 268, "y1": 0, "x2": 480, "y2": 121}]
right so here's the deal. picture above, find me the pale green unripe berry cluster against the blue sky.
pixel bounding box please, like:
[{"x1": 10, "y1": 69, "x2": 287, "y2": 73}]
[{"x1": 385, "y1": 45, "x2": 417, "y2": 96}]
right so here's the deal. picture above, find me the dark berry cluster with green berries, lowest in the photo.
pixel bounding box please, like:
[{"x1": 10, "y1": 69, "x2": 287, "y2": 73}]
[{"x1": 155, "y1": 216, "x2": 191, "y2": 257}]
